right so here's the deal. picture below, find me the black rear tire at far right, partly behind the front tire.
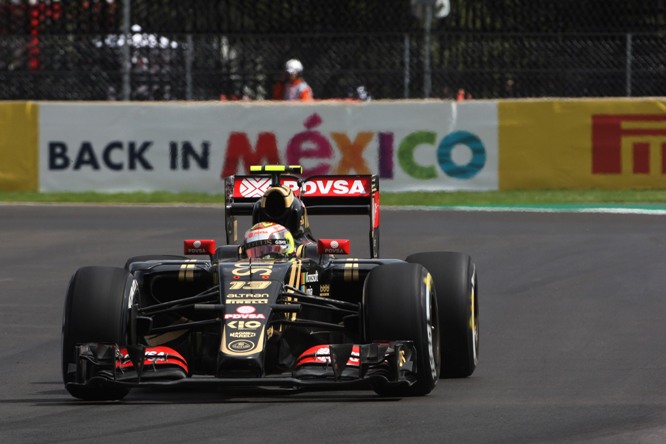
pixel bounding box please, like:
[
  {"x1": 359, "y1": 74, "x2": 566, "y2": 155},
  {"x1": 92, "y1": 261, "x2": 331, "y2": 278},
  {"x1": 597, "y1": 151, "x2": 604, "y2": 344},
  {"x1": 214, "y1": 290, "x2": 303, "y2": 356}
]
[{"x1": 407, "y1": 252, "x2": 479, "y2": 378}]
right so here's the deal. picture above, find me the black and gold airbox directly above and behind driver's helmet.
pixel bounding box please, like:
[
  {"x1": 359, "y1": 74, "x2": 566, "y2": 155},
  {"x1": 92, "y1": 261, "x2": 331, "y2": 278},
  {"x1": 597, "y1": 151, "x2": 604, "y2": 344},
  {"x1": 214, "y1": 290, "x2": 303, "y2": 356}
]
[{"x1": 252, "y1": 185, "x2": 310, "y2": 238}]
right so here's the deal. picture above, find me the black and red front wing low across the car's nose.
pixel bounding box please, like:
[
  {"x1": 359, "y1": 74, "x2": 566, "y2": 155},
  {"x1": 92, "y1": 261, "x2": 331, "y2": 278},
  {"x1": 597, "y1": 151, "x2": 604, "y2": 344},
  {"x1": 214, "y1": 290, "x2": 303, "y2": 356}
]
[{"x1": 62, "y1": 341, "x2": 416, "y2": 390}]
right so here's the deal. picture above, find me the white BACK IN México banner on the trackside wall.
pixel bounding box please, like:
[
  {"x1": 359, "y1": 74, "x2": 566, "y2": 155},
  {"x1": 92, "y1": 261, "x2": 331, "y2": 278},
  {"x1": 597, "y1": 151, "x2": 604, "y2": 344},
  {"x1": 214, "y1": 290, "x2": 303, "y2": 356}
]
[{"x1": 39, "y1": 101, "x2": 498, "y2": 193}]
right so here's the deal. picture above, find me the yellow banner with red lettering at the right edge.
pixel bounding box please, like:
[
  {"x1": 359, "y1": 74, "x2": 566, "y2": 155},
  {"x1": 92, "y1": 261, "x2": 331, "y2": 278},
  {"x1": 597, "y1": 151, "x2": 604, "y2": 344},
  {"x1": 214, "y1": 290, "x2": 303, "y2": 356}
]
[{"x1": 498, "y1": 99, "x2": 666, "y2": 190}]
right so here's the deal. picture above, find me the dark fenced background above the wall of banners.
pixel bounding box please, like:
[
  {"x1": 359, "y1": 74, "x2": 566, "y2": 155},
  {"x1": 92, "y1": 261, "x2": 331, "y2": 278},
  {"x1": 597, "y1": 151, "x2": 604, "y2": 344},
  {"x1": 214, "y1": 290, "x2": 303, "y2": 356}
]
[{"x1": 0, "y1": 0, "x2": 666, "y2": 100}]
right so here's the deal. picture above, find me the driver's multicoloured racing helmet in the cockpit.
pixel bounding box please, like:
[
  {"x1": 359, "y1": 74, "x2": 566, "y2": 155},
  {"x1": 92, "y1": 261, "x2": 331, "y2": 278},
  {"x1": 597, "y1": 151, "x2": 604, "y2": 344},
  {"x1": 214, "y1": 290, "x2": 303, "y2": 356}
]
[{"x1": 243, "y1": 222, "x2": 294, "y2": 259}]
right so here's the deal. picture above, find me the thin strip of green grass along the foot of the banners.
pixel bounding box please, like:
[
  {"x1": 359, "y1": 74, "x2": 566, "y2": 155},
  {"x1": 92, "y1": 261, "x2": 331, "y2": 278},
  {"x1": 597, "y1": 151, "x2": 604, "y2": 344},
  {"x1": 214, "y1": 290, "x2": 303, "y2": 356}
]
[{"x1": 0, "y1": 190, "x2": 666, "y2": 206}]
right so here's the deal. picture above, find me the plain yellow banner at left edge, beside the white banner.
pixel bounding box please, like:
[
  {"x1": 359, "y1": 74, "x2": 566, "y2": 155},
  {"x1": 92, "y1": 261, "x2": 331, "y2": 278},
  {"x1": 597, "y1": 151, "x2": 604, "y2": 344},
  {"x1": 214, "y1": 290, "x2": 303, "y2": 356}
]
[{"x1": 0, "y1": 102, "x2": 38, "y2": 191}]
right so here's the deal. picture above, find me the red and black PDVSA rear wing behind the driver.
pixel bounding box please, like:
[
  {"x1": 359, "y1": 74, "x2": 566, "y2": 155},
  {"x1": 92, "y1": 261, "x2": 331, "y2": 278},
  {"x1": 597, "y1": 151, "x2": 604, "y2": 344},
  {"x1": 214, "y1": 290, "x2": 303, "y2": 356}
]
[{"x1": 224, "y1": 167, "x2": 379, "y2": 258}]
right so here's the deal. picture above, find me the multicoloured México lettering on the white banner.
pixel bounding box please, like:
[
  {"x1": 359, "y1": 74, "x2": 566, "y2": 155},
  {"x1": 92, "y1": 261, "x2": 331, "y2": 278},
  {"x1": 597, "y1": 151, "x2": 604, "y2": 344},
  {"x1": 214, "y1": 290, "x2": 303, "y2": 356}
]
[{"x1": 221, "y1": 113, "x2": 486, "y2": 179}]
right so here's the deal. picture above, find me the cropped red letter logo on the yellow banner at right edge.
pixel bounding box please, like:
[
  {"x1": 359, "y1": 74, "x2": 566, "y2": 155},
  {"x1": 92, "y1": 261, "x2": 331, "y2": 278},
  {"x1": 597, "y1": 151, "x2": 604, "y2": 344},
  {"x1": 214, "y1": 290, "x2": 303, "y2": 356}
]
[{"x1": 592, "y1": 114, "x2": 666, "y2": 175}]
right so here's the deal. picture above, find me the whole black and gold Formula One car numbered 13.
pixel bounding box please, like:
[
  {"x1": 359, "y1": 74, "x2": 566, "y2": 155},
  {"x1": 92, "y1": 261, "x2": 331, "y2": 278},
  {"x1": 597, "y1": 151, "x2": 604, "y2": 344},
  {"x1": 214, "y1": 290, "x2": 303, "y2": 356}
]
[{"x1": 62, "y1": 165, "x2": 479, "y2": 400}]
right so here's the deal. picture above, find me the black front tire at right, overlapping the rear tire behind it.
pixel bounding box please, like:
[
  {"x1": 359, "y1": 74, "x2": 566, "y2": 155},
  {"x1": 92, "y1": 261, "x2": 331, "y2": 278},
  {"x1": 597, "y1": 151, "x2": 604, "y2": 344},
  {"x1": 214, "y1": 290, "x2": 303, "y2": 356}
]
[{"x1": 363, "y1": 263, "x2": 440, "y2": 396}]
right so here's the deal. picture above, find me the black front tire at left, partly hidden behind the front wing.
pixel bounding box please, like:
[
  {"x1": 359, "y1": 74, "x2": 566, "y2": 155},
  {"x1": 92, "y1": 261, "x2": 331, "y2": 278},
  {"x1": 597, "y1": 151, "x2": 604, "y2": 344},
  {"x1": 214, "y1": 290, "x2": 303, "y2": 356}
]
[{"x1": 62, "y1": 267, "x2": 137, "y2": 401}]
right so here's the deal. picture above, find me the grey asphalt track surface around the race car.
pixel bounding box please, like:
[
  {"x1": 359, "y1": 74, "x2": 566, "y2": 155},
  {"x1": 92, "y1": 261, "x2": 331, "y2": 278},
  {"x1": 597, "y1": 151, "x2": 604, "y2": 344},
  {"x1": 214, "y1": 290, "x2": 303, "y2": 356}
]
[{"x1": 0, "y1": 205, "x2": 666, "y2": 443}]
